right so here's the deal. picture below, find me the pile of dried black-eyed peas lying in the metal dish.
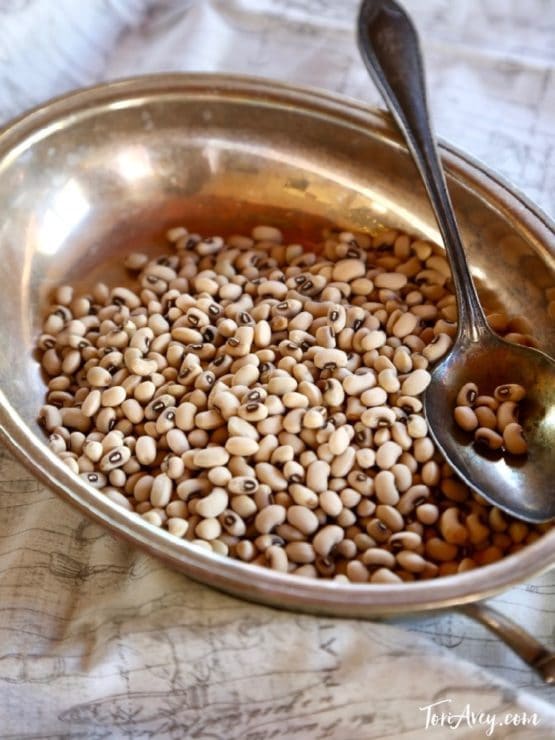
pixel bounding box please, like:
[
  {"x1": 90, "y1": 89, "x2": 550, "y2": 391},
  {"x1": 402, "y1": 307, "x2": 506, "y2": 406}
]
[{"x1": 38, "y1": 226, "x2": 545, "y2": 583}]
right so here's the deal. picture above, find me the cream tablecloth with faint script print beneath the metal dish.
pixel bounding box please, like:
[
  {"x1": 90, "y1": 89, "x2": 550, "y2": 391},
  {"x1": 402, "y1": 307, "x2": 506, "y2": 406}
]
[{"x1": 0, "y1": 0, "x2": 555, "y2": 740}]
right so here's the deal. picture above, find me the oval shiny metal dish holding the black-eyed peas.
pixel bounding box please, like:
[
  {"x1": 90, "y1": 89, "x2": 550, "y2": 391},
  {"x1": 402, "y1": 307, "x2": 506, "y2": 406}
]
[{"x1": 0, "y1": 75, "x2": 555, "y2": 617}]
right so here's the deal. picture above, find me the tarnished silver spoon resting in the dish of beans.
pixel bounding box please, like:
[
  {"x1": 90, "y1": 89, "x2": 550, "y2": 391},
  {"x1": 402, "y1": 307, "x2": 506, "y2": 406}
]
[{"x1": 358, "y1": 0, "x2": 555, "y2": 522}]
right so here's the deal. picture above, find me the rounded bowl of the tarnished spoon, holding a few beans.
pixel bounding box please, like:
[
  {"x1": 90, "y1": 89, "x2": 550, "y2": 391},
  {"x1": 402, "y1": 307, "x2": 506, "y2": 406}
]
[{"x1": 424, "y1": 332, "x2": 555, "y2": 522}]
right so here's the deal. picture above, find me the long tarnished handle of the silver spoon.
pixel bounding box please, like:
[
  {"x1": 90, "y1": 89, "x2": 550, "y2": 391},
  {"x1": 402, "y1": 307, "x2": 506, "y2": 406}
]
[{"x1": 358, "y1": 0, "x2": 489, "y2": 340}]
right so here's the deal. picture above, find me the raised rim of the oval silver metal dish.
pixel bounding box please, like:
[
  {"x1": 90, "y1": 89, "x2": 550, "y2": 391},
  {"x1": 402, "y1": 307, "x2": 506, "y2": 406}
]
[{"x1": 0, "y1": 73, "x2": 555, "y2": 617}]
